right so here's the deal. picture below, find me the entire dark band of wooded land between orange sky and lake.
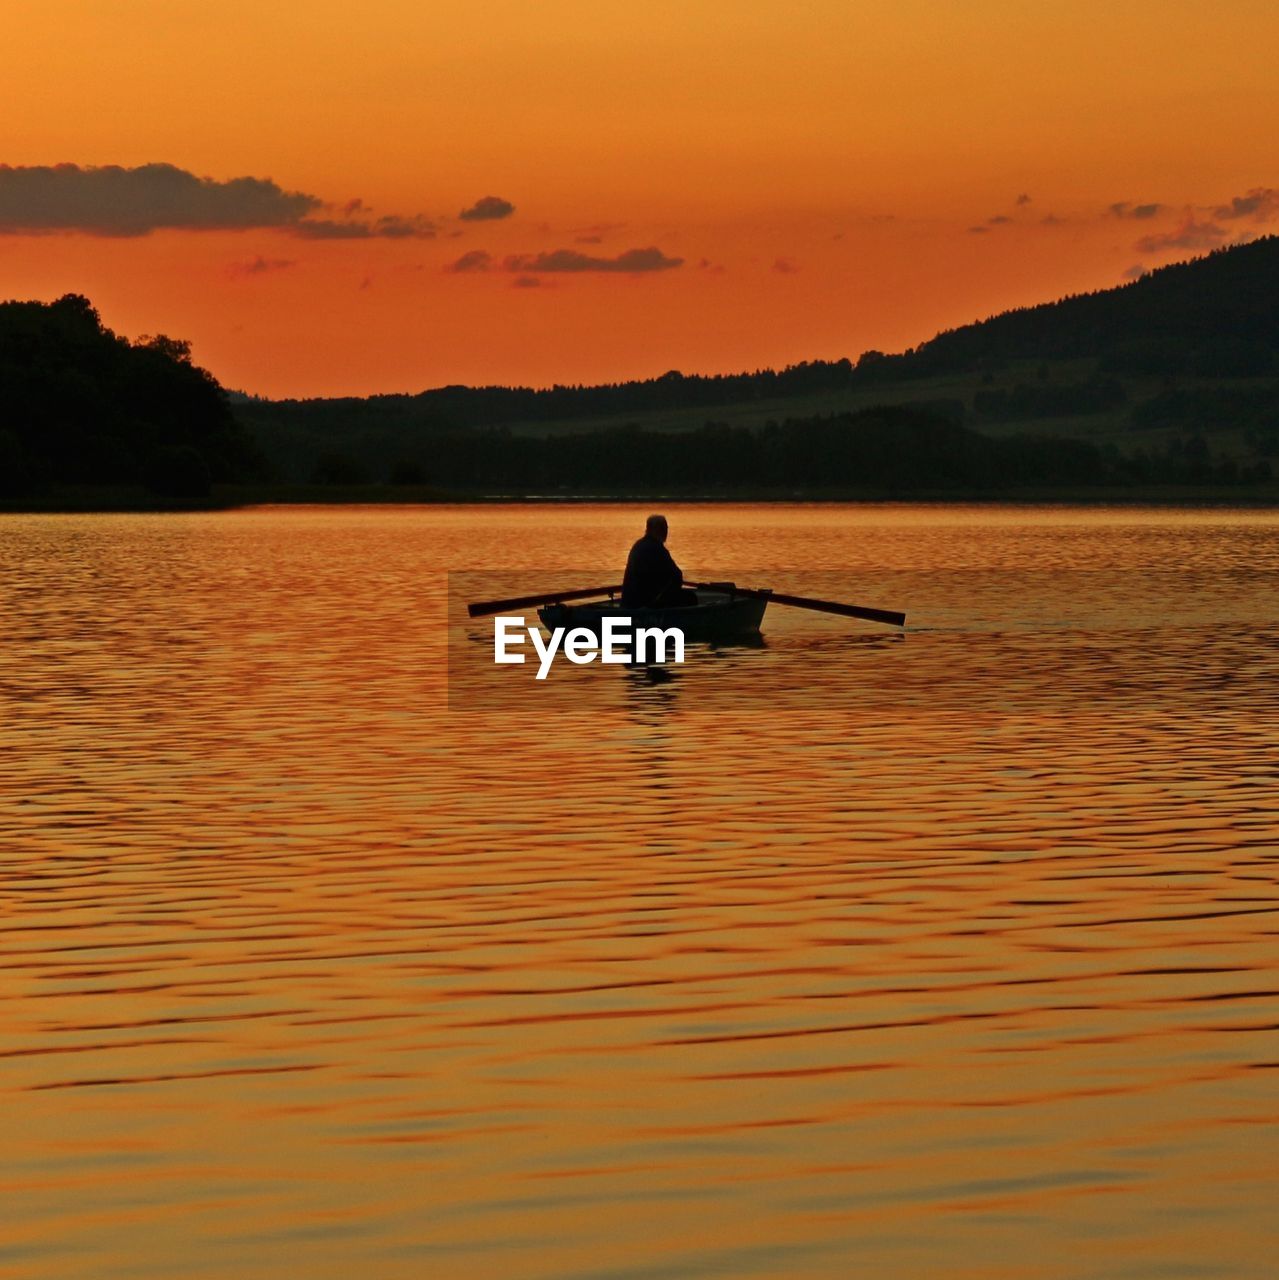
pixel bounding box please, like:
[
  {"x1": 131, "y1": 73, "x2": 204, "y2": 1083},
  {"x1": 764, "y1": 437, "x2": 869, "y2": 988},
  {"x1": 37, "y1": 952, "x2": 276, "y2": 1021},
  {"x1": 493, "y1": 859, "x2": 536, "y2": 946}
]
[{"x1": 0, "y1": 237, "x2": 1279, "y2": 499}]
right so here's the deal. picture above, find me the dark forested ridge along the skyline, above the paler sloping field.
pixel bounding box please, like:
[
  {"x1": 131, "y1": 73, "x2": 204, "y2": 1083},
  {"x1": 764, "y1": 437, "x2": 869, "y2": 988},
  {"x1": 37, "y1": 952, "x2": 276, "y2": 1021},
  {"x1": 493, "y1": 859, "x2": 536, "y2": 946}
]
[{"x1": 234, "y1": 236, "x2": 1279, "y2": 430}]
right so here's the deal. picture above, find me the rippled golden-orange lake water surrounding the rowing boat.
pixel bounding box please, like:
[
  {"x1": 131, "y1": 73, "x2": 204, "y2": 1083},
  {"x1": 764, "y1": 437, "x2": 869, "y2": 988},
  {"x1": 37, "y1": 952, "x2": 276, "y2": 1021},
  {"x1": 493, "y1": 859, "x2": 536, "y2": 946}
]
[{"x1": 0, "y1": 507, "x2": 1279, "y2": 1280}]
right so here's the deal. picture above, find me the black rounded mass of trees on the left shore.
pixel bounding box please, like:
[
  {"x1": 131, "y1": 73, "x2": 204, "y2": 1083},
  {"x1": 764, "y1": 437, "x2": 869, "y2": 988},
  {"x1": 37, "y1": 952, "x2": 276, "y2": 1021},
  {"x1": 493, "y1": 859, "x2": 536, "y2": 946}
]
[{"x1": 0, "y1": 294, "x2": 255, "y2": 498}]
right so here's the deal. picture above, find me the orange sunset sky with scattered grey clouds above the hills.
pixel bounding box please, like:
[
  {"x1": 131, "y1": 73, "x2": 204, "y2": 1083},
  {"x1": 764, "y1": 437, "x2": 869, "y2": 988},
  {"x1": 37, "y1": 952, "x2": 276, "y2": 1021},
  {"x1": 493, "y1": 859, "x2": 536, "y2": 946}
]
[{"x1": 0, "y1": 0, "x2": 1279, "y2": 396}]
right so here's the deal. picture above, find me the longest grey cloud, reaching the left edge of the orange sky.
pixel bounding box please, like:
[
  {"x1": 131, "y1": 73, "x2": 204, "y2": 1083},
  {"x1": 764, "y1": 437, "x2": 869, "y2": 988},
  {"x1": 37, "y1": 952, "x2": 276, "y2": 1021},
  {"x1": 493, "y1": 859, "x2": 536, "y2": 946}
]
[{"x1": 0, "y1": 164, "x2": 435, "y2": 239}]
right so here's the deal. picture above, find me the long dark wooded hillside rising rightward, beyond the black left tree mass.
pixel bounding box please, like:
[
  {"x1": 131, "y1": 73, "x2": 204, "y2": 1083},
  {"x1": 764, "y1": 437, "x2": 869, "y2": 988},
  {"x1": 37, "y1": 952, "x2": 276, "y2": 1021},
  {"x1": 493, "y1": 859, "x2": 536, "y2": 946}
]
[{"x1": 233, "y1": 237, "x2": 1279, "y2": 490}]
